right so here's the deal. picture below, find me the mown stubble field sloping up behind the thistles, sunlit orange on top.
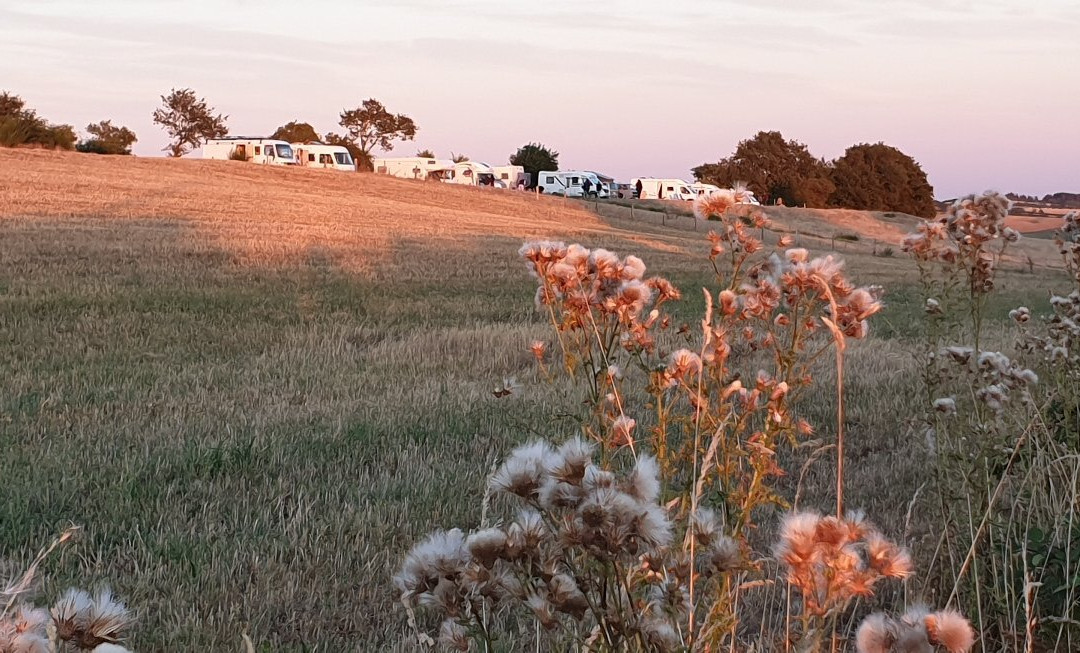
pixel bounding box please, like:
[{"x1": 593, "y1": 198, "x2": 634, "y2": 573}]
[{"x1": 0, "y1": 150, "x2": 1059, "y2": 651}]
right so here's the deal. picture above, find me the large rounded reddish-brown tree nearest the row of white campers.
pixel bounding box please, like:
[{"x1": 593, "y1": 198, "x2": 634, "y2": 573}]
[{"x1": 692, "y1": 132, "x2": 832, "y2": 207}]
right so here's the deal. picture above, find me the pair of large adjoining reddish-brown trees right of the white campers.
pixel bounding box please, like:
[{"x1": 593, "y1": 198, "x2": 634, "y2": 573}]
[{"x1": 692, "y1": 132, "x2": 936, "y2": 218}]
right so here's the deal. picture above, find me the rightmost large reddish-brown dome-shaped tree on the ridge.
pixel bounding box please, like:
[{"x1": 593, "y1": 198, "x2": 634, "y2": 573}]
[{"x1": 829, "y1": 142, "x2": 936, "y2": 218}]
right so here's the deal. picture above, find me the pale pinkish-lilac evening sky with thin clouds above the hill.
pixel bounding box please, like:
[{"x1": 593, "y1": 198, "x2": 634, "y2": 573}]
[{"x1": 0, "y1": 0, "x2": 1080, "y2": 199}]
